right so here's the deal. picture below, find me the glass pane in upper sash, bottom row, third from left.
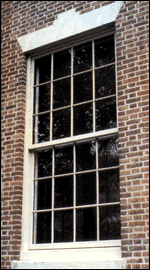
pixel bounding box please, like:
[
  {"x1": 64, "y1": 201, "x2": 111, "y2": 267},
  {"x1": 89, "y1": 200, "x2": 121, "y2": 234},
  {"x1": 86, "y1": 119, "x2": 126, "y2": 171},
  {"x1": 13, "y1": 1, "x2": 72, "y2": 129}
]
[{"x1": 74, "y1": 103, "x2": 93, "y2": 135}]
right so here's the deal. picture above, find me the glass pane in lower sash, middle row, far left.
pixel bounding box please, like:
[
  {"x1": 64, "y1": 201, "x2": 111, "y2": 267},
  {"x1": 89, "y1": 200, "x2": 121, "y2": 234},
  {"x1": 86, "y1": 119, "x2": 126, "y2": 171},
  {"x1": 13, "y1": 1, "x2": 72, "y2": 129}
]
[{"x1": 35, "y1": 179, "x2": 52, "y2": 210}]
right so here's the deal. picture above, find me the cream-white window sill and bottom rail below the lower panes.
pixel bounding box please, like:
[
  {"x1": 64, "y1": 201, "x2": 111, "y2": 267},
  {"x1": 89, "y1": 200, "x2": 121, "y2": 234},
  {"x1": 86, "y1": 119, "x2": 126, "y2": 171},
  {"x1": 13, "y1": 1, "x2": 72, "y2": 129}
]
[{"x1": 17, "y1": 240, "x2": 123, "y2": 269}]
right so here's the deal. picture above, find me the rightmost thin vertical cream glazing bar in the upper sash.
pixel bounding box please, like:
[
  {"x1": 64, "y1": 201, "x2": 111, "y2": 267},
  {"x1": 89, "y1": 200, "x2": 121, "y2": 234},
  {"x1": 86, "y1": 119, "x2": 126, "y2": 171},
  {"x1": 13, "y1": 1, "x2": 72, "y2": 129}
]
[{"x1": 92, "y1": 40, "x2": 95, "y2": 132}]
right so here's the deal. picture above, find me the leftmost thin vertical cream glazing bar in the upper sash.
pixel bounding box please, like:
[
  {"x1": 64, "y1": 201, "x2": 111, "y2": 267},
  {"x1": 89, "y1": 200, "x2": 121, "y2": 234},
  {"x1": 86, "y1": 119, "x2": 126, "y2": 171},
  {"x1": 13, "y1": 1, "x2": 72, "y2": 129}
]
[{"x1": 50, "y1": 54, "x2": 54, "y2": 141}]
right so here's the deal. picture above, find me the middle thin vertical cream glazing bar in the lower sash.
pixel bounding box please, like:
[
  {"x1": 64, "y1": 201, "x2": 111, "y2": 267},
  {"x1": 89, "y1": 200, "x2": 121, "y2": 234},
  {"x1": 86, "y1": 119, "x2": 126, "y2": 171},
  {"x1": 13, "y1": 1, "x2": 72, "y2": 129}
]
[{"x1": 73, "y1": 143, "x2": 76, "y2": 242}]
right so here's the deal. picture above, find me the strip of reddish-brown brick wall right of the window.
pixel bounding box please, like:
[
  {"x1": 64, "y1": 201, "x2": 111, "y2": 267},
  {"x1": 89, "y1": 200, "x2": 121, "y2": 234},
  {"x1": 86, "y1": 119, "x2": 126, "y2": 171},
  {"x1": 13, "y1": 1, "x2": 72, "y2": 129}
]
[{"x1": 116, "y1": 1, "x2": 149, "y2": 269}]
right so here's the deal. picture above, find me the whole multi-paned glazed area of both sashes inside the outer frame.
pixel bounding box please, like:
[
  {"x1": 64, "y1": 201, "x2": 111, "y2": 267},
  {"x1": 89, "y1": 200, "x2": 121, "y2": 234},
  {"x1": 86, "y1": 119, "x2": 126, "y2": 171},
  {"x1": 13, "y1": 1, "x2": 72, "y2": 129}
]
[{"x1": 32, "y1": 33, "x2": 120, "y2": 244}]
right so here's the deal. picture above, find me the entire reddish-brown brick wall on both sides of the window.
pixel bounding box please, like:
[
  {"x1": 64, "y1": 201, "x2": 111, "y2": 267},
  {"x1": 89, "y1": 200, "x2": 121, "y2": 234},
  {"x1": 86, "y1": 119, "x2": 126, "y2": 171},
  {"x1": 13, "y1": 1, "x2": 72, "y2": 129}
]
[{"x1": 1, "y1": 1, "x2": 149, "y2": 269}]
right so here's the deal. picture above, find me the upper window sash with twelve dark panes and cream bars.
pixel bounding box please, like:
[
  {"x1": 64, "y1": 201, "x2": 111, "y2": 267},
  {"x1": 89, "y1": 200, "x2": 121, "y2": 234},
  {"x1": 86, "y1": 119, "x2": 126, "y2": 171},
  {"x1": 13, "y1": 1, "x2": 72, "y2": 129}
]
[{"x1": 30, "y1": 36, "x2": 117, "y2": 149}]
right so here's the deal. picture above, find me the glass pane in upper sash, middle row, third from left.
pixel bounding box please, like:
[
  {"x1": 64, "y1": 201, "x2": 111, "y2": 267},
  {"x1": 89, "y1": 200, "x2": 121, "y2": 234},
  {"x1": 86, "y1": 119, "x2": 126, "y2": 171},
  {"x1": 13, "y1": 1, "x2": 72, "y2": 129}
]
[{"x1": 74, "y1": 72, "x2": 92, "y2": 103}]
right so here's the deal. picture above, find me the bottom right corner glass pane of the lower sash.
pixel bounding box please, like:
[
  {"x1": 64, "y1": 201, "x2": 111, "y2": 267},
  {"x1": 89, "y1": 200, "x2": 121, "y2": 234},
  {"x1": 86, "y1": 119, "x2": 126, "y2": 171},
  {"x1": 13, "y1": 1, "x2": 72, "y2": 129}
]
[{"x1": 100, "y1": 205, "x2": 120, "y2": 240}]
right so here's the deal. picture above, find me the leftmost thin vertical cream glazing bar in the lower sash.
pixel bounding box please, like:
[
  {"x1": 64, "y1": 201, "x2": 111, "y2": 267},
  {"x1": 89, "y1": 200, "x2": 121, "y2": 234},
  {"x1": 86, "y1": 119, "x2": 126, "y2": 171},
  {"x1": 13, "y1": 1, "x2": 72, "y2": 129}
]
[{"x1": 51, "y1": 147, "x2": 55, "y2": 243}]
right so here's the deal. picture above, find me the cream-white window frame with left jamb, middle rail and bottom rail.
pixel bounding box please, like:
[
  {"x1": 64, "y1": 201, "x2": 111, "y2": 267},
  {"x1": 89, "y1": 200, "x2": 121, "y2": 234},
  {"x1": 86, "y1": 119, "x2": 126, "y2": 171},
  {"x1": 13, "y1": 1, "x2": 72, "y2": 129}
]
[{"x1": 21, "y1": 31, "x2": 121, "y2": 261}]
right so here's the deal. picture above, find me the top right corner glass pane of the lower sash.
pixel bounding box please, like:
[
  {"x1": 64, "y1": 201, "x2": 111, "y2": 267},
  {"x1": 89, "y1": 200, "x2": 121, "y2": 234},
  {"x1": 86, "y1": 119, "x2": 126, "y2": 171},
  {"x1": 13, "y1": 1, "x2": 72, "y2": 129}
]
[{"x1": 98, "y1": 137, "x2": 119, "y2": 168}]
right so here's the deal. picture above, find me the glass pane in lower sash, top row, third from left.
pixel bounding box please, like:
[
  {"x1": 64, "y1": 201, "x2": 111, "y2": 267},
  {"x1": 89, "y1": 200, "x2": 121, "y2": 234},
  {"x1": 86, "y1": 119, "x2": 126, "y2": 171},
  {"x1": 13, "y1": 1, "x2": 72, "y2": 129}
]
[{"x1": 76, "y1": 141, "x2": 96, "y2": 172}]
